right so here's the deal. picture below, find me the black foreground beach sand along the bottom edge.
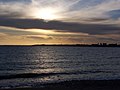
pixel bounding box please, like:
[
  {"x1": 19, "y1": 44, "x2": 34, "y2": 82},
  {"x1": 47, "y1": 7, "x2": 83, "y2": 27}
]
[{"x1": 1, "y1": 80, "x2": 120, "y2": 90}]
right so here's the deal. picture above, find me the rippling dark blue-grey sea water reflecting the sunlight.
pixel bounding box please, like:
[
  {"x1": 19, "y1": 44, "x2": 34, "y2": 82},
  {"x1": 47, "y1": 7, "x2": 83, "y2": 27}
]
[{"x1": 0, "y1": 46, "x2": 120, "y2": 88}]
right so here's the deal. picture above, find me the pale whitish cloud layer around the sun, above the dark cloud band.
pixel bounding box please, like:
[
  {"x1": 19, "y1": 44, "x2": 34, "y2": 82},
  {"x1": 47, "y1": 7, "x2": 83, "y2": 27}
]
[{"x1": 0, "y1": 0, "x2": 120, "y2": 23}]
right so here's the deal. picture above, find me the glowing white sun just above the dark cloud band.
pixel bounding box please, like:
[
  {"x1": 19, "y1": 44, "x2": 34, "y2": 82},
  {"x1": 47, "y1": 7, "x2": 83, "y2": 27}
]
[{"x1": 33, "y1": 8, "x2": 59, "y2": 20}]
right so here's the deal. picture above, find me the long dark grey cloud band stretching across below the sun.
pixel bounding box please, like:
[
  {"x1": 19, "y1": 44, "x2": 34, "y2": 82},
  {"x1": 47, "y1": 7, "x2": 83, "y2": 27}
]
[{"x1": 0, "y1": 18, "x2": 120, "y2": 34}]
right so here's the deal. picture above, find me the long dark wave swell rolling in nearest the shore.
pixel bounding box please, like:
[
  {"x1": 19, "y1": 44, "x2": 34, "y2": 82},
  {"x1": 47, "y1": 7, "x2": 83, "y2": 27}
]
[{"x1": 0, "y1": 71, "x2": 110, "y2": 80}]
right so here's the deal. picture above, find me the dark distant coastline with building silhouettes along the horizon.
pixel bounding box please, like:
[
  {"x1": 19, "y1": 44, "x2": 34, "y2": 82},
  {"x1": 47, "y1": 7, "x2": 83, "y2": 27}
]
[{"x1": 0, "y1": 43, "x2": 120, "y2": 47}]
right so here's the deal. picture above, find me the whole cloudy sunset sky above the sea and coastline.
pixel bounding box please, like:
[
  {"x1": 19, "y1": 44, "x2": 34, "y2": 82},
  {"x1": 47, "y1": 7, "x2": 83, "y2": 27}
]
[{"x1": 0, "y1": 0, "x2": 120, "y2": 45}]
